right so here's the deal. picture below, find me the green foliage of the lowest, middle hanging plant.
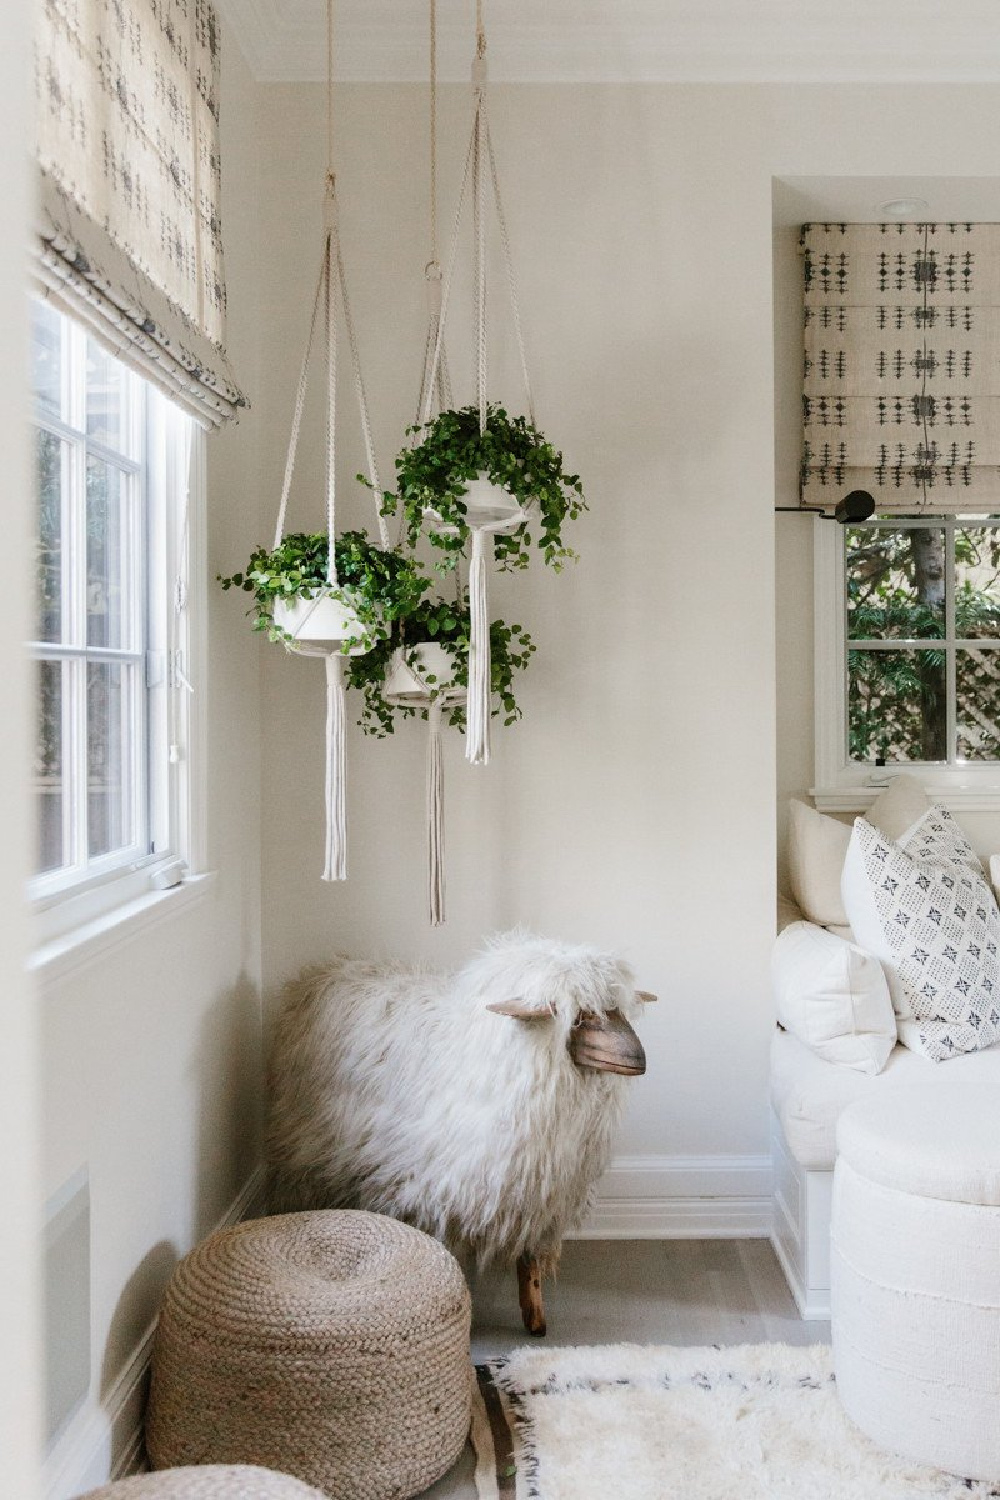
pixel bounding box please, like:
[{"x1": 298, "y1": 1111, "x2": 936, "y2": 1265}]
[{"x1": 346, "y1": 599, "x2": 535, "y2": 738}]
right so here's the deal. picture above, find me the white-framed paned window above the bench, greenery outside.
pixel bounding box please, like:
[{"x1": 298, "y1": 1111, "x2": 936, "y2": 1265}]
[{"x1": 816, "y1": 516, "x2": 1000, "y2": 806}]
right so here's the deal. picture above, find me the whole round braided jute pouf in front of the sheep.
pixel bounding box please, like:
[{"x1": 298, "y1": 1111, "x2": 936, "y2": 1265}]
[{"x1": 145, "y1": 1211, "x2": 472, "y2": 1500}]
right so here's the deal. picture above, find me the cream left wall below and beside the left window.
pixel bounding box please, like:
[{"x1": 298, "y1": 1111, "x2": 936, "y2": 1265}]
[{"x1": 39, "y1": 38, "x2": 261, "y2": 1493}]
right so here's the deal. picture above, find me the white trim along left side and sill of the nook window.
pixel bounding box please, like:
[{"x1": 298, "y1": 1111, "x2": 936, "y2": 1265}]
[{"x1": 811, "y1": 516, "x2": 1000, "y2": 813}]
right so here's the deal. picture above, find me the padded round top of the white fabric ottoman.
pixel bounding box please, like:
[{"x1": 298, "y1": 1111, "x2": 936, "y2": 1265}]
[{"x1": 837, "y1": 1086, "x2": 1000, "y2": 1208}]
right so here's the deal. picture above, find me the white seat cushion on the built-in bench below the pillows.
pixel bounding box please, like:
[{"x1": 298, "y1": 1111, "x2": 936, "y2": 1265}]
[{"x1": 771, "y1": 1031, "x2": 1000, "y2": 1172}]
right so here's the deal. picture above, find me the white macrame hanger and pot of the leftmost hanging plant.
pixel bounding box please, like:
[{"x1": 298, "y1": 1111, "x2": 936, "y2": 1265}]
[{"x1": 274, "y1": 0, "x2": 390, "y2": 881}]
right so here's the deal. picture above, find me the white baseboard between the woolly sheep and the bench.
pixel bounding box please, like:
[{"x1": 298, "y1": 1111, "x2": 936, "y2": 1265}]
[{"x1": 571, "y1": 1157, "x2": 774, "y2": 1239}]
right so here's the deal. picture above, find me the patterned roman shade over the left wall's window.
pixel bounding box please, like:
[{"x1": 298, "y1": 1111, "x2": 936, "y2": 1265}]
[{"x1": 34, "y1": 0, "x2": 244, "y2": 425}]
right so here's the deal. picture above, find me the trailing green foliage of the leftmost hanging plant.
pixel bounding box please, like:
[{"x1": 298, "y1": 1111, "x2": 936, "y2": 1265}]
[{"x1": 219, "y1": 531, "x2": 430, "y2": 645}]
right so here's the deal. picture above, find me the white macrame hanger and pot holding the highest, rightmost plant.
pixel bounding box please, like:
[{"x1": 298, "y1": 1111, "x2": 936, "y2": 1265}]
[{"x1": 420, "y1": 0, "x2": 535, "y2": 765}]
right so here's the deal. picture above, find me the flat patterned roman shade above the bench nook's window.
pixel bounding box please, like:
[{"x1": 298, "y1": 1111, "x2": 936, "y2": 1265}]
[{"x1": 801, "y1": 224, "x2": 1000, "y2": 515}]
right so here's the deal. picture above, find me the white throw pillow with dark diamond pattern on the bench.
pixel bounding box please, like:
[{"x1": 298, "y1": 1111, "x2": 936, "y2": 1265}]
[{"x1": 843, "y1": 807, "x2": 1000, "y2": 1062}]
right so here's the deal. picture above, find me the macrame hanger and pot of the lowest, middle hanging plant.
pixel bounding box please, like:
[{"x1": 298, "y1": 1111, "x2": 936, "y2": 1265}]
[{"x1": 385, "y1": 0, "x2": 465, "y2": 927}]
